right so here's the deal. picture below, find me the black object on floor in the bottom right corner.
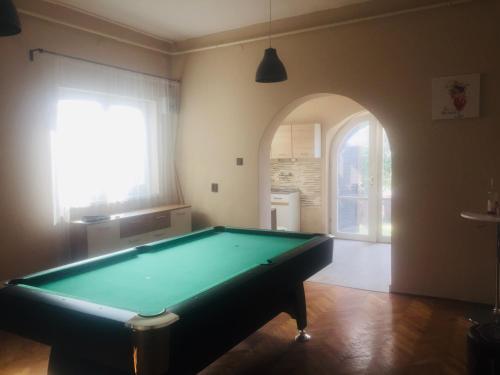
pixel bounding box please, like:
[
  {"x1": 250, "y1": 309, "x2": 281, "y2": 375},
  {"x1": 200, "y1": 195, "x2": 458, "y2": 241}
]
[{"x1": 467, "y1": 323, "x2": 500, "y2": 375}]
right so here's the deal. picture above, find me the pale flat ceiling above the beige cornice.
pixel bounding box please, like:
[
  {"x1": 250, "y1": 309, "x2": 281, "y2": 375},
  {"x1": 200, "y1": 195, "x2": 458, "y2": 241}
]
[{"x1": 45, "y1": 0, "x2": 368, "y2": 41}]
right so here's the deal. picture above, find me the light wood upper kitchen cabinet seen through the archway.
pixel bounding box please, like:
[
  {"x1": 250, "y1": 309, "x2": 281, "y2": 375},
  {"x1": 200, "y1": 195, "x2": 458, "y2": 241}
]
[{"x1": 271, "y1": 124, "x2": 321, "y2": 159}]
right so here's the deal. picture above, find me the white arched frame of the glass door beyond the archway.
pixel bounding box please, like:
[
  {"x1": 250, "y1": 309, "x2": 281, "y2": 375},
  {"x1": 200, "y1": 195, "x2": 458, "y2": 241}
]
[{"x1": 327, "y1": 112, "x2": 391, "y2": 243}]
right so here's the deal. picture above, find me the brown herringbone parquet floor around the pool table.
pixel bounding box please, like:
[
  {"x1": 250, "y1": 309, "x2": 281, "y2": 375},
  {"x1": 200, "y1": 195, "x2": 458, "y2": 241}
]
[{"x1": 0, "y1": 282, "x2": 471, "y2": 375}]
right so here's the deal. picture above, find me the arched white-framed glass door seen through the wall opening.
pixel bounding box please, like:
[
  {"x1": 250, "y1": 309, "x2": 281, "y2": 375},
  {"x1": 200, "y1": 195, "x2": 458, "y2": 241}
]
[{"x1": 331, "y1": 114, "x2": 391, "y2": 242}]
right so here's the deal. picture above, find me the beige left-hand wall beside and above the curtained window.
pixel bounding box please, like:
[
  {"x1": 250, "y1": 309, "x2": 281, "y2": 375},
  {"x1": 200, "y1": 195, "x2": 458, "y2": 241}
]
[{"x1": 0, "y1": 15, "x2": 169, "y2": 280}]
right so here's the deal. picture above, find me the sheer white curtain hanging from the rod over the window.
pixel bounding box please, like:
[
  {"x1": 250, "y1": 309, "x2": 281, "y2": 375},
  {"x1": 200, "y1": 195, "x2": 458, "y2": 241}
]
[{"x1": 37, "y1": 54, "x2": 179, "y2": 223}]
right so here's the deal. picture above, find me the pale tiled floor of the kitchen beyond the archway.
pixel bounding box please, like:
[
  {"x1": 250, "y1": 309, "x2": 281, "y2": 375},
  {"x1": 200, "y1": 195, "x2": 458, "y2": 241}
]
[{"x1": 309, "y1": 239, "x2": 391, "y2": 292}]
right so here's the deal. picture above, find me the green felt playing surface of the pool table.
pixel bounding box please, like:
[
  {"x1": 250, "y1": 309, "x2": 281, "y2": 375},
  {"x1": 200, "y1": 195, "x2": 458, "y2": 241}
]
[{"x1": 19, "y1": 231, "x2": 311, "y2": 314}]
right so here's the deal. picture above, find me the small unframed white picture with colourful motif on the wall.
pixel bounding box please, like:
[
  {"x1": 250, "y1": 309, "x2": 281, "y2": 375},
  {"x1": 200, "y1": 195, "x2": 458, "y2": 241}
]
[{"x1": 432, "y1": 74, "x2": 481, "y2": 120}]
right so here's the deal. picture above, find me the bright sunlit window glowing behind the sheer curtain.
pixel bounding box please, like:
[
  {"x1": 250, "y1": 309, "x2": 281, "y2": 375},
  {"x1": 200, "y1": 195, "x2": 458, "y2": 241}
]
[{"x1": 52, "y1": 89, "x2": 159, "y2": 220}]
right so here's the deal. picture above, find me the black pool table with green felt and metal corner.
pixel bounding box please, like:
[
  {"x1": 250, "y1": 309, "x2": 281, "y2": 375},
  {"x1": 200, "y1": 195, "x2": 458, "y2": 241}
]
[{"x1": 0, "y1": 227, "x2": 333, "y2": 375}]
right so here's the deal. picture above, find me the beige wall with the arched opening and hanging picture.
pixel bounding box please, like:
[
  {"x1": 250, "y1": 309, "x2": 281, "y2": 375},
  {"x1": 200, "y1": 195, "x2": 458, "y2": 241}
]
[{"x1": 173, "y1": 0, "x2": 500, "y2": 302}]
